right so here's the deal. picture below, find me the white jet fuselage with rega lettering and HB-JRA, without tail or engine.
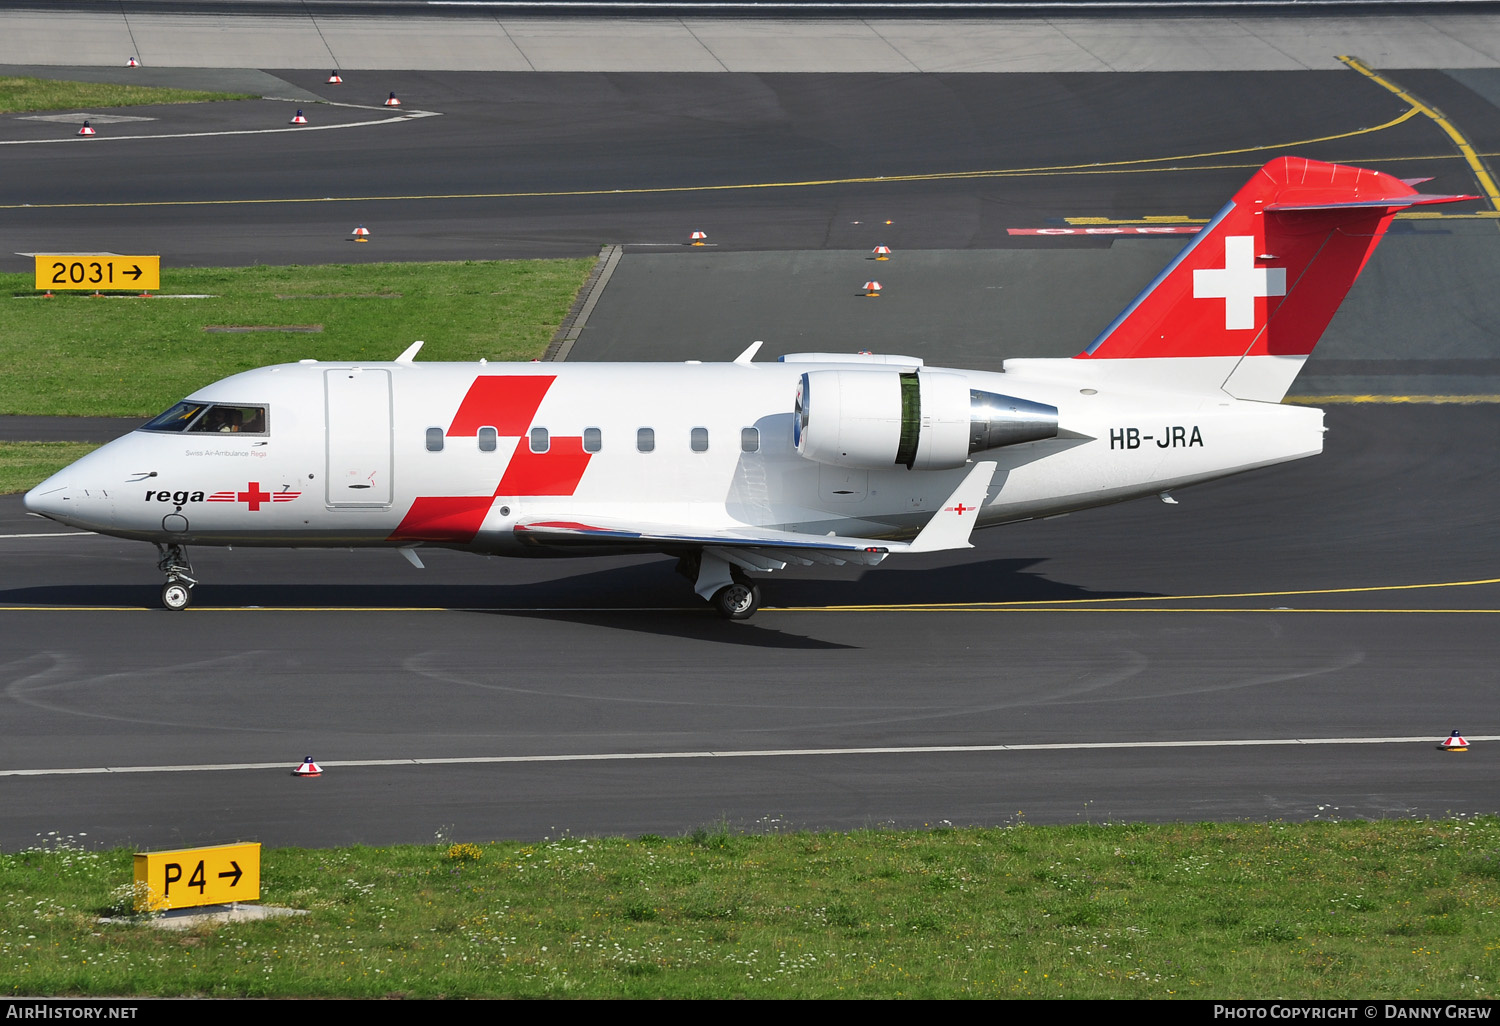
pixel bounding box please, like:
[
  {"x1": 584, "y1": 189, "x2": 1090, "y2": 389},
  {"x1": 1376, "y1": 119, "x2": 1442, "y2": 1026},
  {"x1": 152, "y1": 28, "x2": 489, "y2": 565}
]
[{"x1": 27, "y1": 359, "x2": 1322, "y2": 555}]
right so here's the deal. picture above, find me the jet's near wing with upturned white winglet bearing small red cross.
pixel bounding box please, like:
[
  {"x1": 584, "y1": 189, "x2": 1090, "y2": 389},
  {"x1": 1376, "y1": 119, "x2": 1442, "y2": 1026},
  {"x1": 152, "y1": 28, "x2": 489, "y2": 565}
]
[{"x1": 515, "y1": 462, "x2": 996, "y2": 572}]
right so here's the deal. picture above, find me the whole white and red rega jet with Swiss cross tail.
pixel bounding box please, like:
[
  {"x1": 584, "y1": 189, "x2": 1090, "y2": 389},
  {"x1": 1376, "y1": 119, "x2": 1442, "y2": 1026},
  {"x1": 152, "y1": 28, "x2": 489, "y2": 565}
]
[{"x1": 26, "y1": 158, "x2": 1475, "y2": 620}]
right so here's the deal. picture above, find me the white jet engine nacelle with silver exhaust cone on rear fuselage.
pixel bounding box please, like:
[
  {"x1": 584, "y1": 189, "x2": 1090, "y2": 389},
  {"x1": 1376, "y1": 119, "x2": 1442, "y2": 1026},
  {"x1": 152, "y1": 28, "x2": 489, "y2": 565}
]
[{"x1": 792, "y1": 369, "x2": 1058, "y2": 470}]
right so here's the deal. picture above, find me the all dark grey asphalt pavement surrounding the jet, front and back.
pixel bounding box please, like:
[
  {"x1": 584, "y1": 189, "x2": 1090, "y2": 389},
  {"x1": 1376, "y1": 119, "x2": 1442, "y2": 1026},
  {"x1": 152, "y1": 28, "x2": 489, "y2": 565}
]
[{"x1": 0, "y1": 14, "x2": 1500, "y2": 849}]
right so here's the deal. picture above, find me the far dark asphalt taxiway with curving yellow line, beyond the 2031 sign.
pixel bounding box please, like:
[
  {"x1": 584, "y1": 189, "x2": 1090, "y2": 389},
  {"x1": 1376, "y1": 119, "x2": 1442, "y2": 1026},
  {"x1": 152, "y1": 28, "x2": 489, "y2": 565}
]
[{"x1": 0, "y1": 68, "x2": 1482, "y2": 264}]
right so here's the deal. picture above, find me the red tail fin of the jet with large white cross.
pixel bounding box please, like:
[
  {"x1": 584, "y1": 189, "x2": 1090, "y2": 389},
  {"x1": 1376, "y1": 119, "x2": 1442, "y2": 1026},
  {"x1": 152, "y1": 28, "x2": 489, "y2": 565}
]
[{"x1": 1079, "y1": 158, "x2": 1478, "y2": 402}]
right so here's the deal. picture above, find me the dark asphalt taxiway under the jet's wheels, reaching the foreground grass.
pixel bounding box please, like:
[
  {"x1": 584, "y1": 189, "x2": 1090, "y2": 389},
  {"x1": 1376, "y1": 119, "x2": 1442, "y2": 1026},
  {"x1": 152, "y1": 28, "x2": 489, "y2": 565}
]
[{"x1": 0, "y1": 405, "x2": 1500, "y2": 846}]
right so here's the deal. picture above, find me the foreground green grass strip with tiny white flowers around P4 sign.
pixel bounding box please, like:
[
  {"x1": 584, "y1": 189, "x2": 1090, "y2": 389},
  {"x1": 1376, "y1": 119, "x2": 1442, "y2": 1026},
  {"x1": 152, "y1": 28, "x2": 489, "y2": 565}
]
[{"x1": 0, "y1": 816, "x2": 1500, "y2": 999}]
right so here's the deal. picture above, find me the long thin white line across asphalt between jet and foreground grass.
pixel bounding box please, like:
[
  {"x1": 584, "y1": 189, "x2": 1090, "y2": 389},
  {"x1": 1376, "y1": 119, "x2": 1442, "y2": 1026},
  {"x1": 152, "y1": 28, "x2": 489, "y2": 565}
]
[{"x1": 0, "y1": 735, "x2": 1500, "y2": 777}]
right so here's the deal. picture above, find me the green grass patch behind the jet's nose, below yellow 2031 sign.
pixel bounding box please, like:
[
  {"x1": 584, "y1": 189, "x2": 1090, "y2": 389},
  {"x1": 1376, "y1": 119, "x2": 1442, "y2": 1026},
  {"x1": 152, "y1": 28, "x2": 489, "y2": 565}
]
[{"x1": 0, "y1": 261, "x2": 594, "y2": 417}]
